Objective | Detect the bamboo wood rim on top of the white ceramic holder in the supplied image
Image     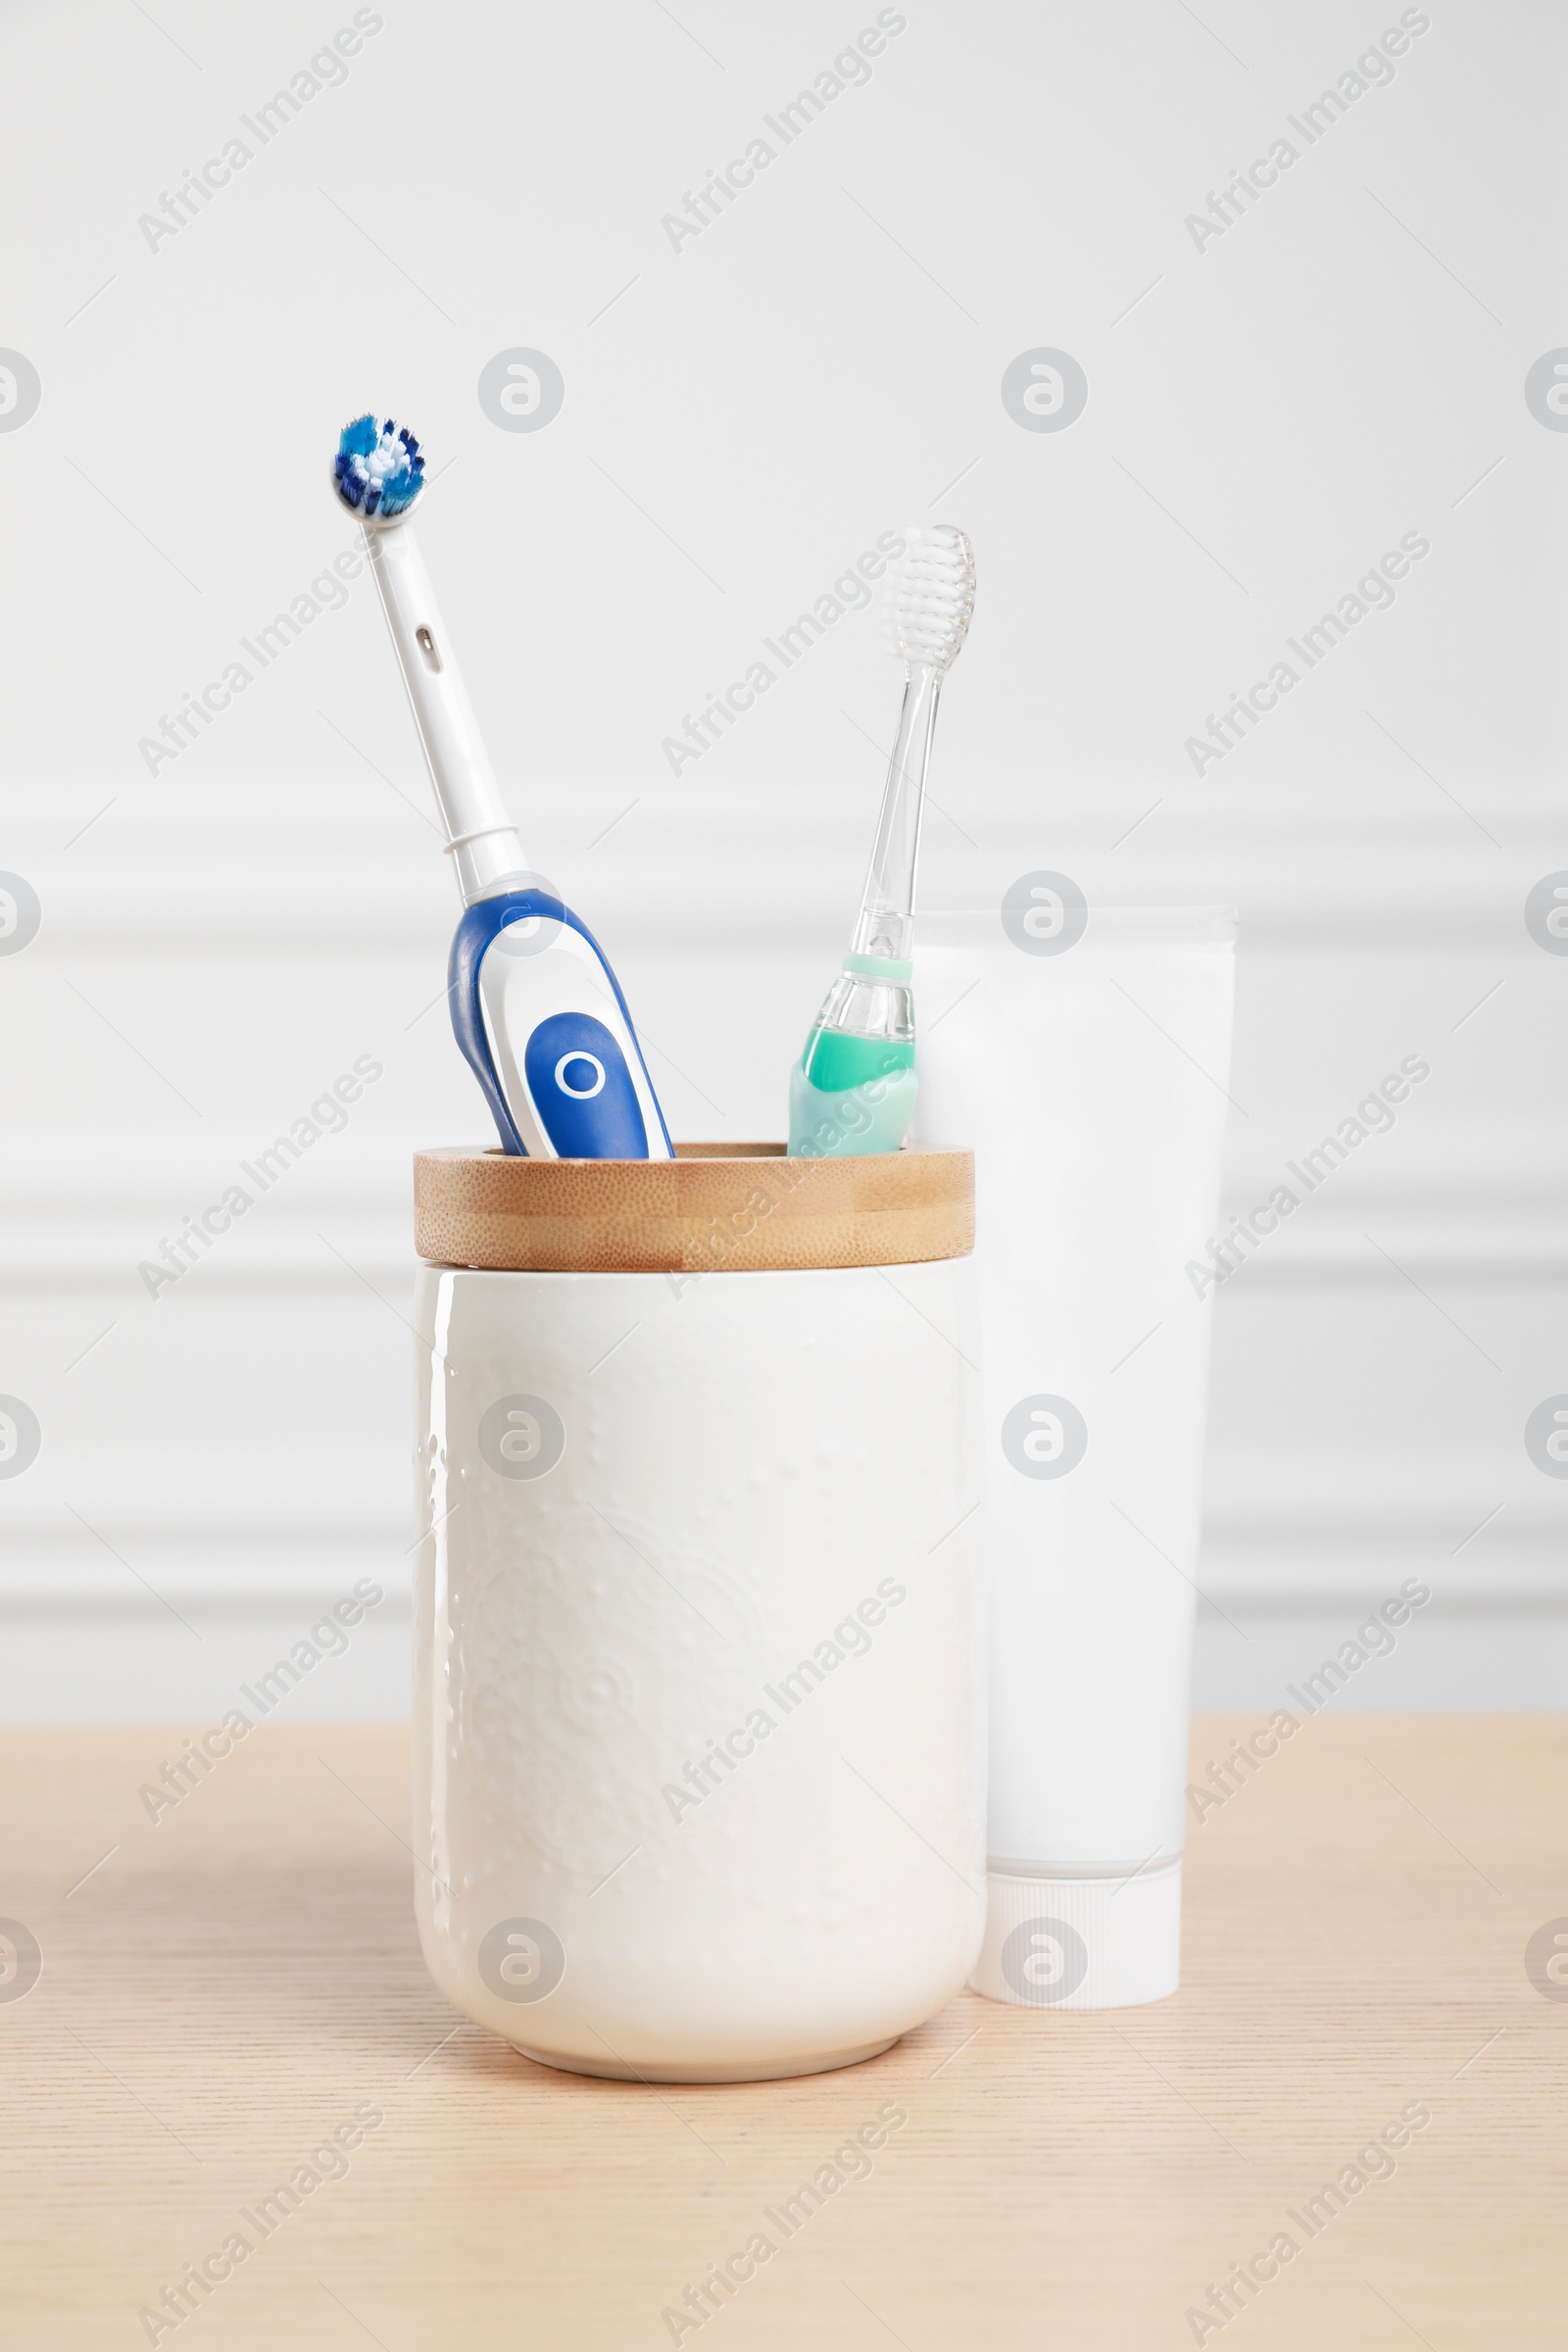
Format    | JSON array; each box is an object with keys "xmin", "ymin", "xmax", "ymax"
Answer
[{"xmin": 414, "ymin": 1143, "xmax": 976, "ymax": 1275}]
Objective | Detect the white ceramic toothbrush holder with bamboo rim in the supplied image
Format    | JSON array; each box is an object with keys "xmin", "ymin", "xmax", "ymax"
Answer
[{"xmin": 414, "ymin": 1146, "xmax": 985, "ymax": 2082}]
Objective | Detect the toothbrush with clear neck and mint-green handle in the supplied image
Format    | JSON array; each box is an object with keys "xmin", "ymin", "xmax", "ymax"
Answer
[{"xmin": 790, "ymin": 522, "xmax": 976, "ymax": 1159}]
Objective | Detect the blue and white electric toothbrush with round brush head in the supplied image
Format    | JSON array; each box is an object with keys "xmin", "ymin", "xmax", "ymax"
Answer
[{"xmin": 334, "ymin": 416, "xmax": 674, "ymax": 1159}]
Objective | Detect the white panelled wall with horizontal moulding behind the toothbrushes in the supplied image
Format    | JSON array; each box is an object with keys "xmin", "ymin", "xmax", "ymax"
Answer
[{"xmin": 0, "ymin": 0, "xmax": 1568, "ymax": 1719}]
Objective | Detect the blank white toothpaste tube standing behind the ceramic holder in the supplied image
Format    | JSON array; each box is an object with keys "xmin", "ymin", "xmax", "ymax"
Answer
[{"xmin": 914, "ymin": 898, "xmax": 1234, "ymax": 2009}]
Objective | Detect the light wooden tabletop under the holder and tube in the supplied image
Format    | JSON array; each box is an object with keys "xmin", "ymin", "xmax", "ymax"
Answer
[{"xmin": 0, "ymin": 1717, "xmax": 1568, "ymax": 2352}]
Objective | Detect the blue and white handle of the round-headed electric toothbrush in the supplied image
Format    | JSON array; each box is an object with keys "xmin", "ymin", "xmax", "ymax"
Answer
[{"xmin": 447, "ymin": 889, "xmax": 674, "ymax": 1159}]
